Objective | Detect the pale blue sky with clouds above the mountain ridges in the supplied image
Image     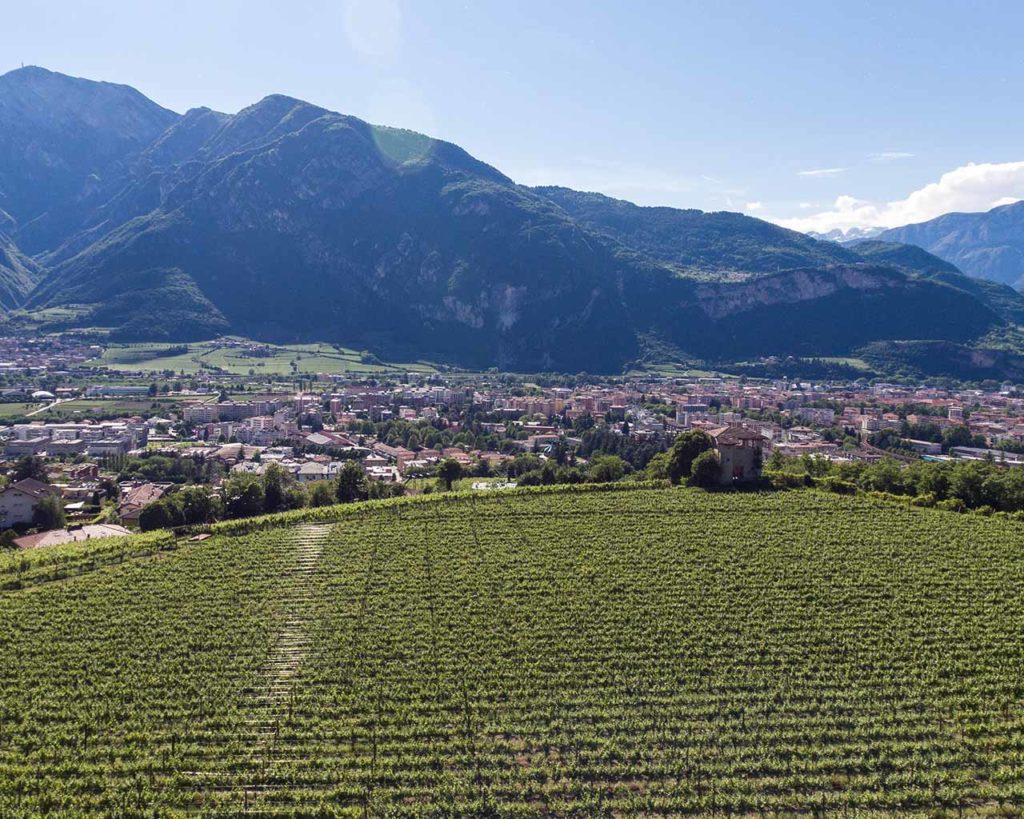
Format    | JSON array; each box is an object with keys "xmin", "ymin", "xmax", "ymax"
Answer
[{"xmin": 0, "ymin": 0, "xmax": 1024, "ymax": 229}]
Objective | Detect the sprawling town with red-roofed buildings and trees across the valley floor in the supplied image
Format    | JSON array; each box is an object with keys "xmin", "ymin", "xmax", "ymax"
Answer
[{"xmin": 0, "ymin": 334, "xmax": 1024, "ymax": 549}]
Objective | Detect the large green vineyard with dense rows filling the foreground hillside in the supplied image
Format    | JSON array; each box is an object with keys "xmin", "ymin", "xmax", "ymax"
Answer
[{"xmin": 0, "ymin": 489, "xmax": 1024, "ymax": 817}]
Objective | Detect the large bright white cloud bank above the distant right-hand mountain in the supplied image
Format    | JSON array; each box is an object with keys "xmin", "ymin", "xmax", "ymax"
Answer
[{"xmin": 776, "ymin": 162, "xmax": 1024, "ymax": 233}]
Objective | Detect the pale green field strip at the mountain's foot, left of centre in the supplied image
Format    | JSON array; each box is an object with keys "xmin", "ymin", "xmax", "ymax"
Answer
[{"xmin": 88, "ymin": 338, "xmax": 434, "ymax": 378}]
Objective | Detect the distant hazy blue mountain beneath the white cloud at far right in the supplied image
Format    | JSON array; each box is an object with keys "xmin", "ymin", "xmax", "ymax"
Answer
[{"xmin": 879, "ymin": 202, "xmax": 1024, "ymax": 290}]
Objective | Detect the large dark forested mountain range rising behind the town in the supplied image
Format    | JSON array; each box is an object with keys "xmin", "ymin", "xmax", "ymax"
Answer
[{"xmin": 0, "ymin": 68, "xmax": 1024, "ymax": 374}]
